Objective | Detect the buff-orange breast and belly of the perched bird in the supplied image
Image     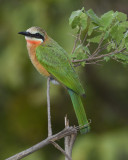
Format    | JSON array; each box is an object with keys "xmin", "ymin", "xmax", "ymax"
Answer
[{"xmin": 27, "ymin": 43, "xmax": 50, "ymax": 77}]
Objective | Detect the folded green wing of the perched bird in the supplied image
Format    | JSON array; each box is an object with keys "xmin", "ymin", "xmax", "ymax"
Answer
[{"xmin": 36, "ymin": 40, "xmax": 84, "ymax": 94}]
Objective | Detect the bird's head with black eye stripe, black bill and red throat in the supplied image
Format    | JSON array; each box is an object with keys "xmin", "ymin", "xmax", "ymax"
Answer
[{"xmin": 19, "ymin": 27, "xmax": 47, "ymax": 44}]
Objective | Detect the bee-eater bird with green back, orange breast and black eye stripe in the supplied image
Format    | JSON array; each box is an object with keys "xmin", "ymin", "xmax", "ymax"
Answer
[{"xmin": 19, "ymin": 27, "xmax": 89, "ymax": 133}]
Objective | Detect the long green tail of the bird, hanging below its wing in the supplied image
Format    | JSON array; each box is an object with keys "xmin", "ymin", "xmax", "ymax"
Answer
[{"xmin": 68, "ymin": 89, "xmax": 90, "ymax": 134}]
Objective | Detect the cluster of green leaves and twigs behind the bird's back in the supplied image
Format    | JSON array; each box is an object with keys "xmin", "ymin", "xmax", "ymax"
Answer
[{"xmin": 69, "ymin": 8, "xmax": 128, "ymax": 65}]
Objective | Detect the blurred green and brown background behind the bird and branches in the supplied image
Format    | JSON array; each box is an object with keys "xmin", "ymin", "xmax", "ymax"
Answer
[{"xmin": 0, "ymin": 0, "xmax": 128, "ymax": 160}]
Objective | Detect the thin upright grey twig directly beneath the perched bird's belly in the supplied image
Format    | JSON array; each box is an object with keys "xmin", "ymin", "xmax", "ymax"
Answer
[{"xmin": 47, "ymin": 77, "xmax": 52, "ymax": 137}]
